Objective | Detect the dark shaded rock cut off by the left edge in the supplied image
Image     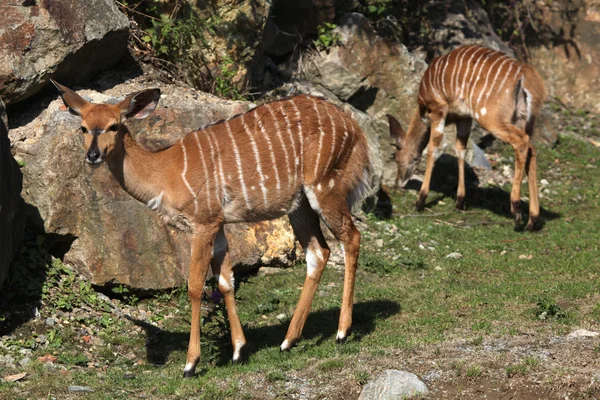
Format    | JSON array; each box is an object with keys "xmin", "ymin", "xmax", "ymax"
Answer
[{"xmin": 0, "ymin": 98, "xmax": 25, "ymax": 287}]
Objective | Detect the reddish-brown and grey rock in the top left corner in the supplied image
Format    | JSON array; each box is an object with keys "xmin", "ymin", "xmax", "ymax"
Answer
[{"xmin": 0, "ymin": 0, "xmax": 129, "ymax": 104}]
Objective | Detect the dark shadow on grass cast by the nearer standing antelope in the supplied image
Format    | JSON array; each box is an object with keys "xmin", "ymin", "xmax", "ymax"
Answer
[{"xmin": 126, "ymin": 300, "xmax": 401, "ymax": 368}]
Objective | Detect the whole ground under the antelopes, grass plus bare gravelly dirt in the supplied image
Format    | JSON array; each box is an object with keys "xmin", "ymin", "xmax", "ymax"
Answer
[{"xmin": 0, "ymin": 111, "xmax": 600, "ymax": 399}]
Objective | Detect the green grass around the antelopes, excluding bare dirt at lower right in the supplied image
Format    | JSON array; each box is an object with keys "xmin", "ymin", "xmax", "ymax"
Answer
[{"xmin": 0, "ymin": 137, "xmax": 600, "ymax": 399}]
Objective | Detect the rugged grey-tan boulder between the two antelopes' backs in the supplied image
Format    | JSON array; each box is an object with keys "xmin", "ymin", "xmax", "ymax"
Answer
[{"xmin": 302, "ymin": 13, "xmax": 427, "ymax": 184}]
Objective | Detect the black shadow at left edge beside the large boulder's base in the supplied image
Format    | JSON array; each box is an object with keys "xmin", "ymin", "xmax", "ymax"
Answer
[{"xmin": 0, "ymin": 204, "xmax": 76, "ymax": 336}]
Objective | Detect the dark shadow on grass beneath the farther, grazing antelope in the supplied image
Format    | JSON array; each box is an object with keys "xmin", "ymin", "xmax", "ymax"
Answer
[{"xmin": 398, "ymin": 154, "xmax": 561, "ymax": 231}]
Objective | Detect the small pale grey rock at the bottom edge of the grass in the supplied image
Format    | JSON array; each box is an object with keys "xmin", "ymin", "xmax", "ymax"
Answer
[{"xmin": 358, "ymin": 369, "xmax": 429, "ymax": 400}]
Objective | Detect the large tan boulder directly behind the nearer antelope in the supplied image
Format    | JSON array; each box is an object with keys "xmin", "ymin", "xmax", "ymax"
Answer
[{"xmin": 10, "ymin": 79, "xmax": 295, "ymax": 289}]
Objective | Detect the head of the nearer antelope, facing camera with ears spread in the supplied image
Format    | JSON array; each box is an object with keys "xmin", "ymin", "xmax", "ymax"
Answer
[{"xmin": 51, "ymin": 80, "xmax": 160, "ymax": 165}]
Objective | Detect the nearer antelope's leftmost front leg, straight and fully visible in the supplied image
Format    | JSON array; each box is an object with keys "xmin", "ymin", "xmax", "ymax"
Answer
[{"xmin": 183, "ymin": 227, "xmax": 217, "ymax": 378}]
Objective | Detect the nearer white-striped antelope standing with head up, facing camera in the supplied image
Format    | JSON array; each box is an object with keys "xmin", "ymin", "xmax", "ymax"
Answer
[{"xmin": 53, "ymin": 81, "xmax": 370, "ymax": 377}]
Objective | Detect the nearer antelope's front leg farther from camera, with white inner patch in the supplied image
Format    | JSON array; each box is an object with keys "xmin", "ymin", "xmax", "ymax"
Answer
[{"xmin": 211, "ymin": 228, "xmax": 246, "ymax": 363}]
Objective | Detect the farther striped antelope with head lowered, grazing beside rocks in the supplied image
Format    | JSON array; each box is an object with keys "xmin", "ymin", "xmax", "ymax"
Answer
[{"xmin": 388, "ymin": 45, "xmax": 546, "ymax": 230}]
